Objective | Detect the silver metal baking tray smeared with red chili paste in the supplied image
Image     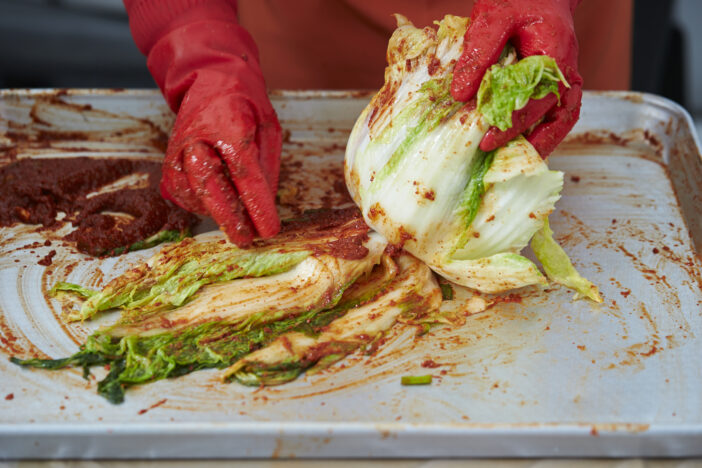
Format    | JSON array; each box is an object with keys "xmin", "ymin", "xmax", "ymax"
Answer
[{"xmin": 0, "ymin": 90, "xmax": 702, "ymax": 458}]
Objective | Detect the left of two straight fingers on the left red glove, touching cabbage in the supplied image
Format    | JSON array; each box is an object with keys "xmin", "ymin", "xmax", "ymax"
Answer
[{"xmin": 183, "ymin": 142, "xmax": 254, "ymax": 247}]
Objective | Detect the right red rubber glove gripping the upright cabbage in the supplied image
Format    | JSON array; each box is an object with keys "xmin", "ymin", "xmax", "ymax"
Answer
[{"xmin": 451, "ymin": 0, "xmax": 583, "ymax": 158}]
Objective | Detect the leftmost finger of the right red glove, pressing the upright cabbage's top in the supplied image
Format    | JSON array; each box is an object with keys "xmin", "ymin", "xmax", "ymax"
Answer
[{"xmin": 451, "ymin": 2, "xmax": 514, "ymax": 102}]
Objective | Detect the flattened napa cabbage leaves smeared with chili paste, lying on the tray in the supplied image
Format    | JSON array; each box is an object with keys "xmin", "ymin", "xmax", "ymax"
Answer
[{"xmin": 11, "ymin": 227, "xmax": 394, "ymax": 403}]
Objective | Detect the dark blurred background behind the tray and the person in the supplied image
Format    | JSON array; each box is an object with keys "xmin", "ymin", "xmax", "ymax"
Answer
[{"xmin": 0, "ymin": 0, "xmax": 702, "ymax": 132}]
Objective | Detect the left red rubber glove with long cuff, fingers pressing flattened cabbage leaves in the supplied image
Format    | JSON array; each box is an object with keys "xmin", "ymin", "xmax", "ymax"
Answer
[{"xmin": 124, "ymin": 0, "xmax": 282, "ymax": 247}]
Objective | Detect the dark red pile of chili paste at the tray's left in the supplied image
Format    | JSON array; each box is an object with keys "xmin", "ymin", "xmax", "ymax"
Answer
[{"xmin": 0, "ymin": 157, "xmax": 197, "ymax": 256}]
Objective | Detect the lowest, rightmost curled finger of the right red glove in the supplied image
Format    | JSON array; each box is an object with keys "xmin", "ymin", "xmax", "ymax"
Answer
[{"xmin": 527, "ymin": 83, "xmax": 583, "ymax": 158}]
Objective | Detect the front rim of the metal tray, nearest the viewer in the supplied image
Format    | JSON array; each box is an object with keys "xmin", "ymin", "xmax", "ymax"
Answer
[{"xmin": 0, "ymin": 422, "xmax": 702, "ymax": 459}]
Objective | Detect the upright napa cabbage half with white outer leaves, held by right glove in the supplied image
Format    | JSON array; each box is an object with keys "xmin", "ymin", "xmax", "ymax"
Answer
[{"xmin": 345, "ymin": 15, "xmax": 599, "ymax": 300}]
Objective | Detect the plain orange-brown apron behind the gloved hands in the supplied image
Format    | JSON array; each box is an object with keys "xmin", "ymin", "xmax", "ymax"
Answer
[{"xmin": 239, "ymin": 0, "xmax": 633, "ymax": 89}]
